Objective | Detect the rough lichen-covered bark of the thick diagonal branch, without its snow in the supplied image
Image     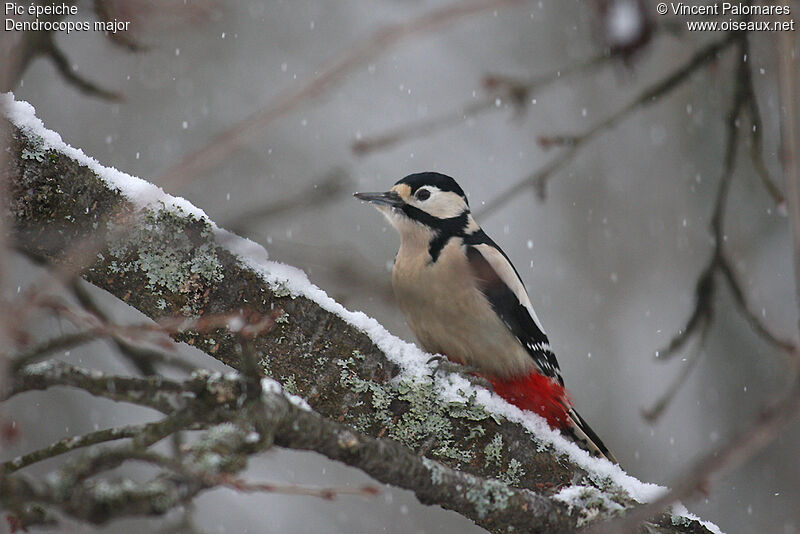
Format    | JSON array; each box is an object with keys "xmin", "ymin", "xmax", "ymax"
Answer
[{"xmin": 3, "ymin": 113, "xmax": 709, "ymax": 533}]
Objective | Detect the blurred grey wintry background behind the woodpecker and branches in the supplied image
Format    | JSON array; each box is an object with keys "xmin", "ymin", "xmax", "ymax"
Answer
[{"xmin": 0, "ymin": 0, "xmax": 800, "ymax": 534}]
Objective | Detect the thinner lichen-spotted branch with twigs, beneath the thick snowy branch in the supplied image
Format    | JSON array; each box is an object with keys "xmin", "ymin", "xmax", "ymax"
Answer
[{"xmin": 0, "ymin": 367, "xmax": 575, "ymax": 534}]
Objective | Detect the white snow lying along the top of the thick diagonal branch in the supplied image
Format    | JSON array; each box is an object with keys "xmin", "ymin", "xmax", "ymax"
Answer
[{"xmin": 0, "ymin": 93, "xmax": 721, "ymax": 534}]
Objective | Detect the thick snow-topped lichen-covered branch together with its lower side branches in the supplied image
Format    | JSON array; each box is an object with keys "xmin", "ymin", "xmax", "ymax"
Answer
[{"xmin": 0, "ymin": 95, "xmax": 719, "ymax": 533}]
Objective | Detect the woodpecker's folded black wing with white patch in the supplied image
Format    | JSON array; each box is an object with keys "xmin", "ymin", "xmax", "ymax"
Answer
[{"xmin": 464, "ymin": 230, "xmax": 564, "ymax": 385}]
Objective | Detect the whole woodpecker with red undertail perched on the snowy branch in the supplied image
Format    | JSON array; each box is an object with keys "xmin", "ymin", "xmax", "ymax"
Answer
[{"xmin": 355, "ymin": 172, "xmax": 616, "ymax": 462}]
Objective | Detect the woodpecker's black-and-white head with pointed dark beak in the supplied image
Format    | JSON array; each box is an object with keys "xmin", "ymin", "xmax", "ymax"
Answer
[{"xmin": 354, "ymin": 172, "xmax": 477, "ymax": 241}]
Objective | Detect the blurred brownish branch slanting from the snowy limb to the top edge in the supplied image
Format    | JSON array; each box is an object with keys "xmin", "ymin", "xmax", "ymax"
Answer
[{"xmin": 158, "ymin": 0, "xmax": 520, "ymax": 190}]
